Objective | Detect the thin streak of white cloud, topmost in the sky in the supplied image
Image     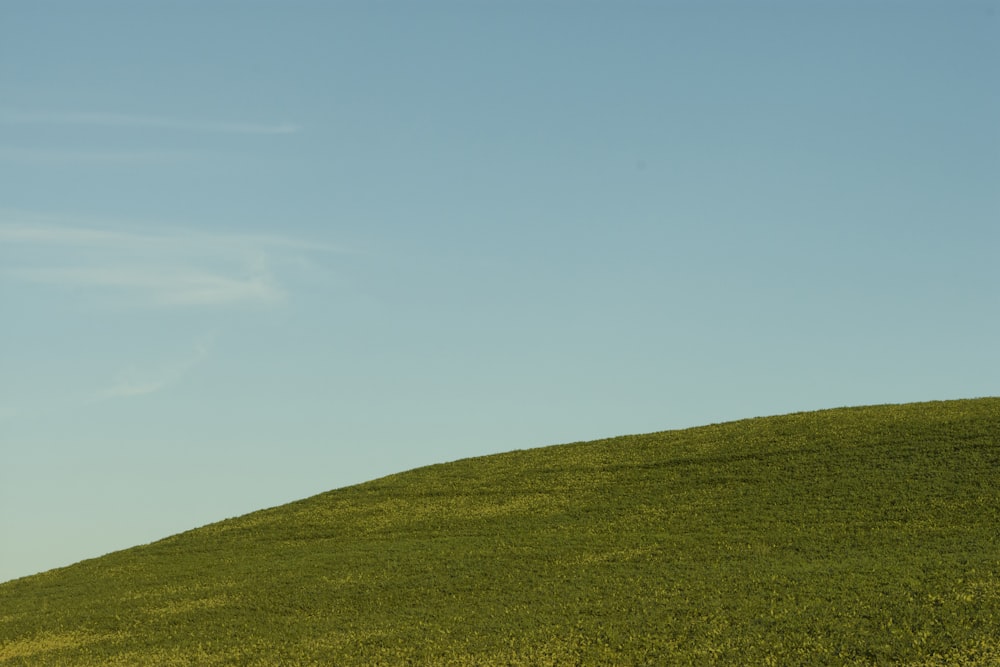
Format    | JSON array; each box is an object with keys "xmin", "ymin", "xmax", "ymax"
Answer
[{"xmin": 0, "ymin": 109, "xmax": 299, "ymax": 134}]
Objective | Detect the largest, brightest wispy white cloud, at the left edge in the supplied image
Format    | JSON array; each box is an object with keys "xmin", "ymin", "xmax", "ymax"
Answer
[{"xmin": 0, "ymin": 214, "xmax": 341, "ymax": 307}]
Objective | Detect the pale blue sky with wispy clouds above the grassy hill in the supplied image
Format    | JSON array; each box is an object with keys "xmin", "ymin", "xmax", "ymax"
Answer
[{"xmin": 0, "ymin": 0, "xmax": 1000, "ymax": 581}]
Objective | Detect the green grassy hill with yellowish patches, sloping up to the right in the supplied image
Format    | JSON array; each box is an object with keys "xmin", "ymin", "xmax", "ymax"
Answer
[{"xmin": 0, "ymin": 398, "xmax": 1000, "ymax": 666}]
